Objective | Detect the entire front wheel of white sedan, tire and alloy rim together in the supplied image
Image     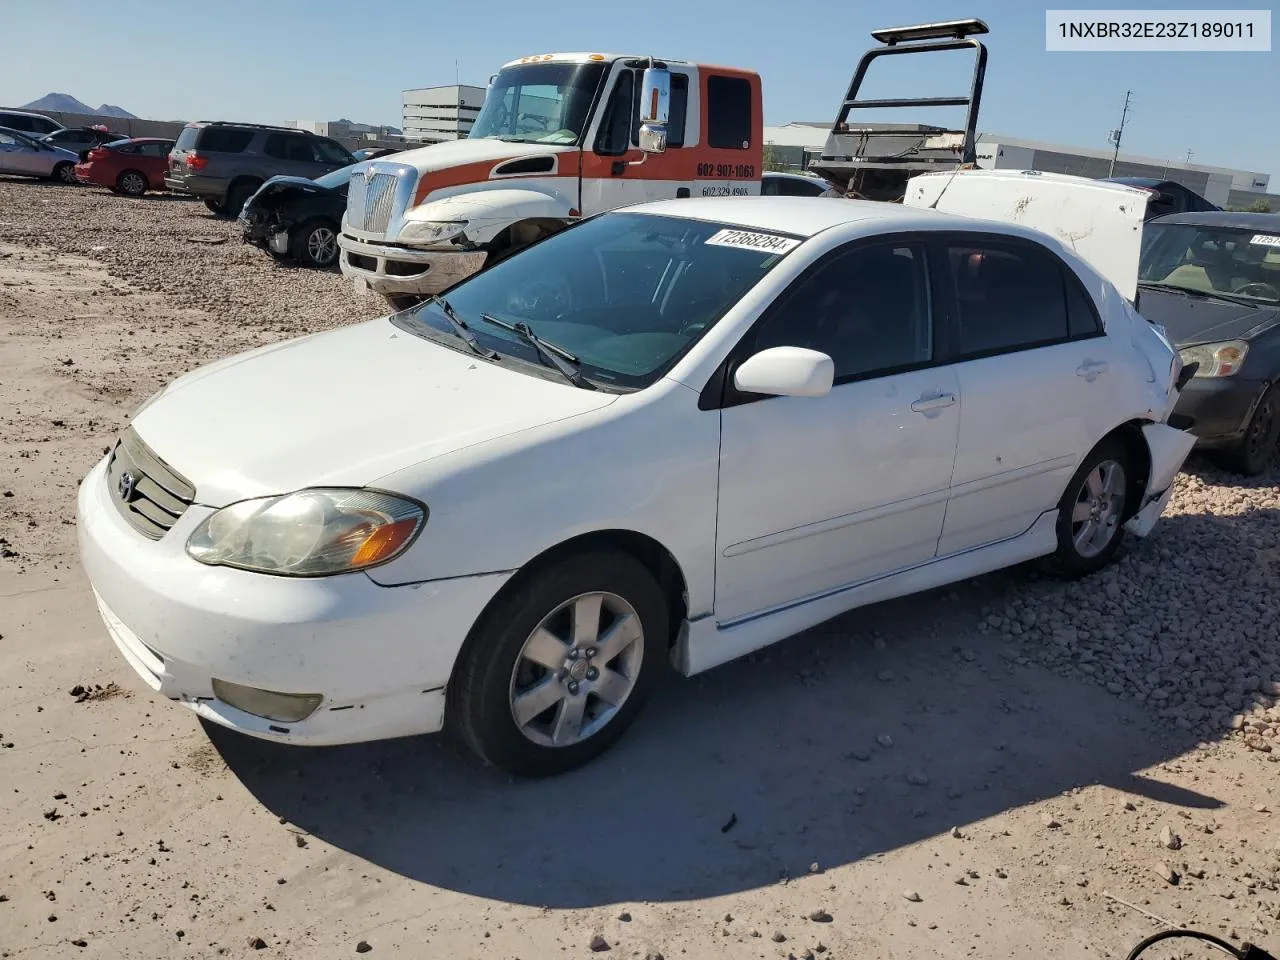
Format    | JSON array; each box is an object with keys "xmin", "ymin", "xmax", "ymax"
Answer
[{"xmin": 448, "ymin": 550, "xmax": 669, "ymax": 777}]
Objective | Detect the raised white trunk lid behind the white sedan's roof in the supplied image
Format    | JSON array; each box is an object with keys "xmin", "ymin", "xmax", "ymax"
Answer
[{"xmin": 902, "ymin": 170, "xmax": 1151, "ymax": 302}]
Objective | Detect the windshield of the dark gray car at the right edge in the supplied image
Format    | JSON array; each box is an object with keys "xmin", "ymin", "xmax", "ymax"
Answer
[{"xmin": 1138, "ymin": 223, "xmax": 1280, "ymax": 302}]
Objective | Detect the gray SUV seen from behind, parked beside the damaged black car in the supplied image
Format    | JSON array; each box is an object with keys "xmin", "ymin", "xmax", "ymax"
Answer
[{"xmin": 164, "ymin": 120, "xmax": 356, "ymax": 216}]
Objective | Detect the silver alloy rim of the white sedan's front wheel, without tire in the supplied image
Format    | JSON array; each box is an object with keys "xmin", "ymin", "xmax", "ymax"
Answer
[{"xmin": 509, "ymin": 593, "xmax": 644, "ymax": 748}]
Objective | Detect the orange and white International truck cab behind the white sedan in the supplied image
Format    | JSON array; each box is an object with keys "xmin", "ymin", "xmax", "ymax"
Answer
[{"xmin": 338, "ymin": 54, "xmax": 764, "ymax": 303}]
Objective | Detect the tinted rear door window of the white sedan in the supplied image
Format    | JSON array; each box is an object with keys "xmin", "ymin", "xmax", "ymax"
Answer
[{"xmin": 947, "ymin": 241, "xmax": 1088, "ymax": 357}]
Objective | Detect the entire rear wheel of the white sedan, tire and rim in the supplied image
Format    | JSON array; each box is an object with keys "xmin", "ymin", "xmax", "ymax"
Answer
[{"xmin": 1053, "ymin": 438, "xmax": 1132, "ymax": 580}]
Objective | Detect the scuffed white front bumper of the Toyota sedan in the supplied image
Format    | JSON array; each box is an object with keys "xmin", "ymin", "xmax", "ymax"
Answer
[{"xmin": 78, "ymin": 458, "xmax": 507, "ymax": 745}]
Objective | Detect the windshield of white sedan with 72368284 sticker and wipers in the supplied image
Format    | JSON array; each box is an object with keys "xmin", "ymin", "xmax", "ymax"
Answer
[{"xmin": 394, "ymin": 212, "xmax": 799, "ymax": 390}]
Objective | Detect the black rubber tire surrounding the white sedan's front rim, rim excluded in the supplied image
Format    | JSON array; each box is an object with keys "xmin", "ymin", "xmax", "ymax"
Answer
[{"xmin": 445, "ymin": 550, "xmax": 671, "ymax": 777}]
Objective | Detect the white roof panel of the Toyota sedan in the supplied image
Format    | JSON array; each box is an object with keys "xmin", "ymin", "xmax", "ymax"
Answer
[{"xmin": 621, "ymin": 197, "xmax": 1003, "ymax": 239}]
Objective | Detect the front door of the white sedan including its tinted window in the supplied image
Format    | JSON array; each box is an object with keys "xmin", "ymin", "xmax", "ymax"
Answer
[{"xmin": 716, "ymin": 239, "xmax": 960, "ymax": 623}]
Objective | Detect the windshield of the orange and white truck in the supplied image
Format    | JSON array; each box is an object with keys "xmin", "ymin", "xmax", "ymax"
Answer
[{"xmin": 468, "ymin": 63, "xmax": 607, "ymax": 145}]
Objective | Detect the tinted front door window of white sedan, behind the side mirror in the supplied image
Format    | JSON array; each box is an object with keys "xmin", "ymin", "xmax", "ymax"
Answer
[{"xmin": 754, "ymin": 243, "xmax": 933, "ymax": 381}]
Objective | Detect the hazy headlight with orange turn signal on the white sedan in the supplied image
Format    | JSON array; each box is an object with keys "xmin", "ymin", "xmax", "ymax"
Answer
[{"xmin": 187, "ymin": 489, "xmax": 426, "ymax": 577}]
